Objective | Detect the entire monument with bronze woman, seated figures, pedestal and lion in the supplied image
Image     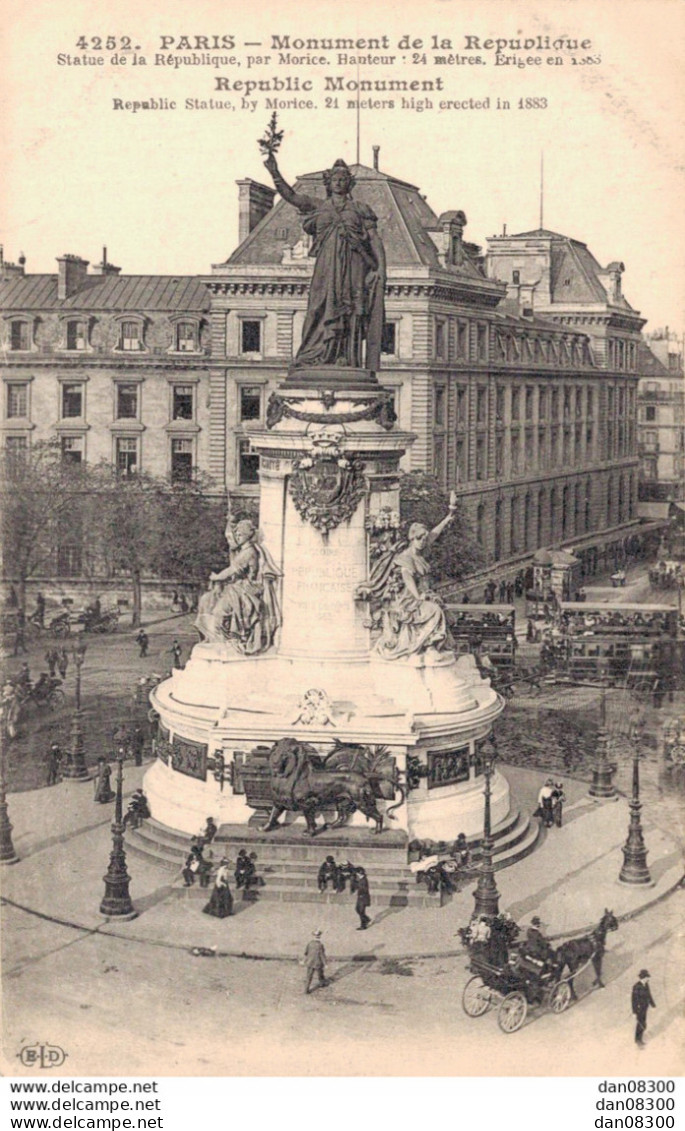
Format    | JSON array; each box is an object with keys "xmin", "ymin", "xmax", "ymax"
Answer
[{"xmin": 145, "ymin": 119, "xmax": 510, "ymax": 844}]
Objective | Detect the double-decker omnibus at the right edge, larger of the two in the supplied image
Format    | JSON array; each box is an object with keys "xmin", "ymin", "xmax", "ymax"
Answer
[{"xmin": 560, "ymin": 602, "xmax": 683, "ymax": 687}]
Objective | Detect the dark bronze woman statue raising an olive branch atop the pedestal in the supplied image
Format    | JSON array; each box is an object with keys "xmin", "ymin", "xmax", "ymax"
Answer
[{"xmin": 265, "ymin": 153, "xmax": 385, "ymax": 372}]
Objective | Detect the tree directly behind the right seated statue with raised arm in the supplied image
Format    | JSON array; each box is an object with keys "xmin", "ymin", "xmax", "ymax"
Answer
[{"xmin": 400, "ymin": 472, "xmax": 485, "ymax": 581}]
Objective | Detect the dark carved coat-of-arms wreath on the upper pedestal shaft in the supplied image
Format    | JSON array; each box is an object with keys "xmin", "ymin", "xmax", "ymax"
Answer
[{"xmin": 289, "ymin": 446, "xmax": 365, "ymax": 535}]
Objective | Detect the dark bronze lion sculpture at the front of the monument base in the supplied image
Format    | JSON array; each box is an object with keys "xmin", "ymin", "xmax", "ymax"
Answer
[{"xmin": 265, "ymin": 739, "xmax": 404, "ymax": 836}]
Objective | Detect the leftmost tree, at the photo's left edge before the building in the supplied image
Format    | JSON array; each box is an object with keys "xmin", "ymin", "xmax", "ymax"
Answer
[{"xmin": 0, "ymin": 440, "xmax": 88, "ymax": 608}]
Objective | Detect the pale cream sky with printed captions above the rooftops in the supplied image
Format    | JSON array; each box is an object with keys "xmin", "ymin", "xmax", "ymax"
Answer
[{"xmin": 0, "ymin": 0, "xmax": 685, "ymax": 334}]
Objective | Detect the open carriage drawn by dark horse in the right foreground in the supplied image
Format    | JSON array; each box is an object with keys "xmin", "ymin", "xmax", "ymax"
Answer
[{"xmin": 461, "ymin": 910, "xmax": 618, "ymax": 1033}]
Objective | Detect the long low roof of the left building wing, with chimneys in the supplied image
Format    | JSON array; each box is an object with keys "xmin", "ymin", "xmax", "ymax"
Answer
[{"xmin": 0, "ymin": 274, "xmax": 210, "ymax": 312}]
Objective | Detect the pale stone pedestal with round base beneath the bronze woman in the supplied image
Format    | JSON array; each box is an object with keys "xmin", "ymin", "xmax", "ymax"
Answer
[{"xmin": 144, "ymin": 370, "xmax": 510, "ymax": 855}]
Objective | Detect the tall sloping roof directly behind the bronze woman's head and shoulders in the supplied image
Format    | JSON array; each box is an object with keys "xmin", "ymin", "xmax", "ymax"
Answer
[{"xmin": 222, "ymin": 165, "xmax": 484, "ymax": 282}]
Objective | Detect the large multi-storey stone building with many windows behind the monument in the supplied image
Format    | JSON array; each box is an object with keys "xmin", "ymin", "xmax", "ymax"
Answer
[{"xmin": 0, "ymin": 154, "xmax": 643, "ymax": 583}]
